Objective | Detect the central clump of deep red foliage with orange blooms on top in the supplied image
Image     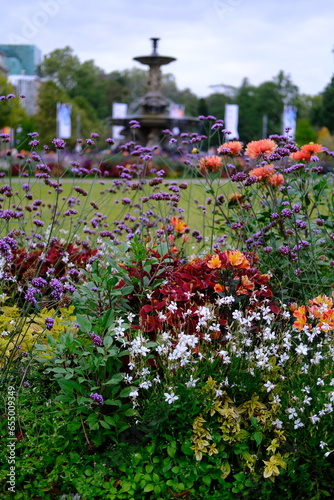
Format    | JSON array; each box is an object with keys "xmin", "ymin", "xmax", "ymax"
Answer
[{"xmin": 120, "ymin": 250, "xmax": 279, "ymax": 338}]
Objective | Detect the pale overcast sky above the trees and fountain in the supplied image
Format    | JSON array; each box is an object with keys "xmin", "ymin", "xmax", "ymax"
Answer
[{"xmin": 0, "ymin": 0, "xmax": 334, "ymax": 97}]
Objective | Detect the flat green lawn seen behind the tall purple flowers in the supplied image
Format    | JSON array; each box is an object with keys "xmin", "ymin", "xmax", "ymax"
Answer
[{"xmin": 6, "ymin": 179, "xmax": 231, "ymax": 243}]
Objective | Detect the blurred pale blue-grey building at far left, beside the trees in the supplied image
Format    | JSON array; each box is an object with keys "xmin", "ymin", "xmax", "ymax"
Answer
[{"xmin": 0, "ymin": 44, "xmax": 42, "ymax": 115}]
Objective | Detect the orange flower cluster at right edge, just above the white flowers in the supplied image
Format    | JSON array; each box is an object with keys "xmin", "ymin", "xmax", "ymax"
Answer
[{"xmin": 291, "ymin": 295, "xmax": 334, "ymax": 332}]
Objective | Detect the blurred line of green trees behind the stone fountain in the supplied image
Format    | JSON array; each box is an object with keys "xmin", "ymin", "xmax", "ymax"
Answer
[{"xmin": 0, "ymin": 46, "xmax": 334, "ymax": 146}]
